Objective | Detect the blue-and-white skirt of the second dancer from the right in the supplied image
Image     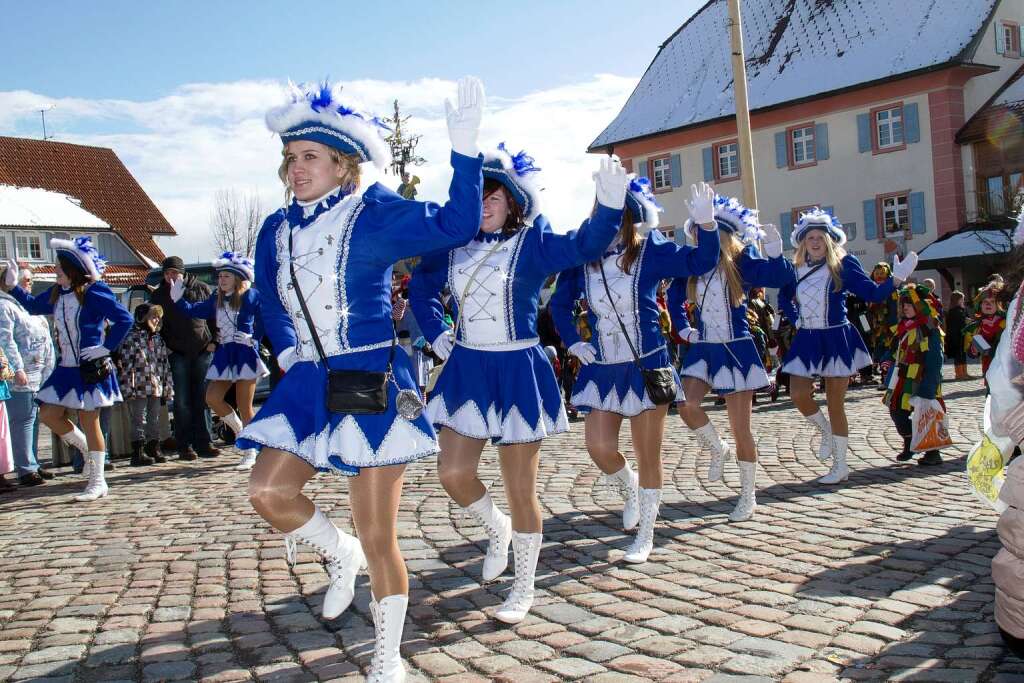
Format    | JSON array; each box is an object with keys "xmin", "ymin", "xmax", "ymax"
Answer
[{"xmin": 679, "ymin": 337, "xmax": 769, "ymax": 396}]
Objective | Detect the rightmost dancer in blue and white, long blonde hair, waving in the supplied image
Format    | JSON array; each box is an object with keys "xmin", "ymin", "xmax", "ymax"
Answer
[{"xmin": 778, "ymin": 208, "xmax": 918, "ymax": 484}]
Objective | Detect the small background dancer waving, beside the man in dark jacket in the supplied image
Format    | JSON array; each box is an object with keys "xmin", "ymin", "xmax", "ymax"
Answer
[{"xmin": 171, "ymin": 252, "xmax": 270, "ymax": 470}]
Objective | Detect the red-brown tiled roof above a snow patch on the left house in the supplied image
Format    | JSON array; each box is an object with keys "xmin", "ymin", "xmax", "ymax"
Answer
[{"xmin": 0, "ymin": 136, "xmax": 177, "ymax": 262}]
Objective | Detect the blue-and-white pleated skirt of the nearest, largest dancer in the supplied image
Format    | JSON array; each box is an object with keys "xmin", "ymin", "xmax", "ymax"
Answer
[{"xmin": 236, "ymin": 347, "xmax": 437, "ymax": 475}]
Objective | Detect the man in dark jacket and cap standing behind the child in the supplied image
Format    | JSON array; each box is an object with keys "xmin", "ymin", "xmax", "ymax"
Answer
[{"xmin": 151, "ymin": 256, "xmax": 218, "ymax": 460}]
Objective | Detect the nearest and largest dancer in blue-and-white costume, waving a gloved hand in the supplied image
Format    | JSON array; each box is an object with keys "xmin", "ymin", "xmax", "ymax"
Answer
[{"xmin": 238, "ymin": 79, "xmax": 483, "ymax": 681}]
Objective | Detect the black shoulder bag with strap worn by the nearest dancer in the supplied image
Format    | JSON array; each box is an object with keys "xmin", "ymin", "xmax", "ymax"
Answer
[{"xmin": 288, "ymin": 226, "xmax": 397, "ymax": 415}]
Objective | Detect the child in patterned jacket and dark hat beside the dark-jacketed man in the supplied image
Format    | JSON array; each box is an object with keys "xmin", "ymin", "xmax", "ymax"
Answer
[{"xmin": 118, "ymin": 303, "xmax": 174, "ymax": 467}]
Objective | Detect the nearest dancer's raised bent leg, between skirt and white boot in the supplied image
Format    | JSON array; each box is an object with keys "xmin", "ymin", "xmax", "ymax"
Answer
[{"xmin": 249, "ymin": 449, "xmax": 316, "ymax": 533}]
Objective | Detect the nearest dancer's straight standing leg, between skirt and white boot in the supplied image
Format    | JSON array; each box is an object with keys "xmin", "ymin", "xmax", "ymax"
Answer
[{"xmin": 348, "ymin": 464, "xmax": 409, "ymax": 601}]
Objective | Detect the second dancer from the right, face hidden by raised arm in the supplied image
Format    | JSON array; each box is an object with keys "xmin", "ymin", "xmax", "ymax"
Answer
[{"xmin": 668, "ymin": 183, "xmax": 793, "ymax": 521}]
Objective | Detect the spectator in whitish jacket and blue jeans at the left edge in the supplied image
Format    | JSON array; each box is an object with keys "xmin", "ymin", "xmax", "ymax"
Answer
[{"xmin": 0, "ymin": 265, "xmax": 55, "ymax": 486}]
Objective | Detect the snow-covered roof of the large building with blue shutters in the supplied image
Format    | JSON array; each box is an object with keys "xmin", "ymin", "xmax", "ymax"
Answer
[{"xmin": 591, "ymin": 0, "xmax": 997, "ymax": 147}]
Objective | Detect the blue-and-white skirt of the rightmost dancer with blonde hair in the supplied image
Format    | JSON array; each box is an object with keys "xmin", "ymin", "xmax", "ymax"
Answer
[{"xmin": 782, "ymin": 323, "xmax": 871, "ymax": 377}]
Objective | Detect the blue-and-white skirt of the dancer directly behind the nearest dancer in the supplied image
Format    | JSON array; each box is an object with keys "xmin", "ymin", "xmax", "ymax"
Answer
[{"xmin": 427, "ymin": 344, "xmax": 569, "ymax": 445}]
